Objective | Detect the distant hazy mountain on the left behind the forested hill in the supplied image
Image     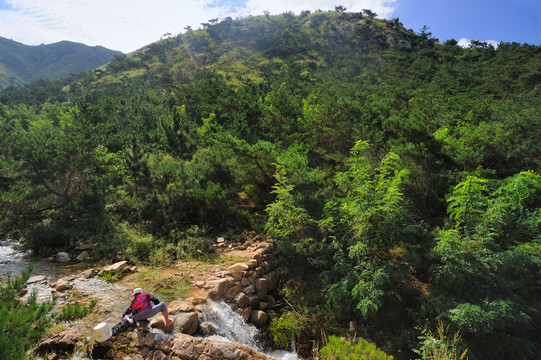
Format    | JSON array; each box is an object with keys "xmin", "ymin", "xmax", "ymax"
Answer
[{"xmin": 0, "ymin": 37, "xmax": 122, "ymax": 89}]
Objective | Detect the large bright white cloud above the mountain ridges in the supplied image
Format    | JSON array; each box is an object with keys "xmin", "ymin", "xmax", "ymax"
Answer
[{"xmin": 0, "ymin": 0, "xmax": 397, "ymax": 52}]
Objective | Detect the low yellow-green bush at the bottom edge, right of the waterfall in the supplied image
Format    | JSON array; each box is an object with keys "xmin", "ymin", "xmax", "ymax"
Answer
[{"xmin": 320, "ymin": 335, "xmax": 393, "ymax": 360}]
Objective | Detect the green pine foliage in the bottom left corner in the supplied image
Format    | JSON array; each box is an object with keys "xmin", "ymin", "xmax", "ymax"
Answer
[{"xmin": 0, "ymin": 269, "xmax": 55, "ymax": 360}]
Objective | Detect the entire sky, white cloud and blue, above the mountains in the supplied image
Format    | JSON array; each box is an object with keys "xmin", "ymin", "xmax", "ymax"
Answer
[{"xmin": 0, "ymin": 0, "xmax": 541, "ymax": 53}]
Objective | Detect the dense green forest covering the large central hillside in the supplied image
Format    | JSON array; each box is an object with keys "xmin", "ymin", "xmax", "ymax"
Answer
[{"xmin": 0, "ymin": 12, "xmax": 541, "ymax": 359}]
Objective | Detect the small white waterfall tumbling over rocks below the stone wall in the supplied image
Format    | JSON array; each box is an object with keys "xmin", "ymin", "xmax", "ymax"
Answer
[{"xmin": 204, "ymin": 303, "xmax": 300, "ymax": 360}]
